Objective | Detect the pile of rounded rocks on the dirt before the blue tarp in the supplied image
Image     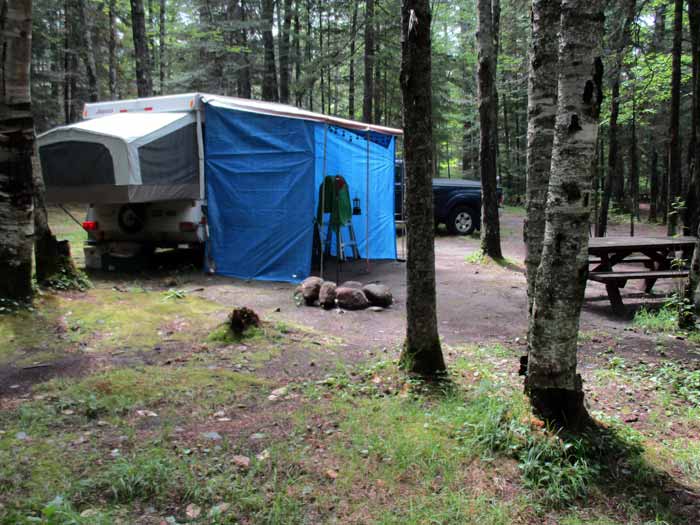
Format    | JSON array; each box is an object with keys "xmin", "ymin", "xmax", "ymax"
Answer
[{"xmin": 294, "ymin": 277, "xmax": 394, "ymax": 310}]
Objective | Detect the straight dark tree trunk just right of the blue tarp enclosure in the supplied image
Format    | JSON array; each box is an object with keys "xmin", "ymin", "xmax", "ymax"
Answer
[{"xmin": 396, "ymin": 0, "xmax": 445, "ymax": 376}]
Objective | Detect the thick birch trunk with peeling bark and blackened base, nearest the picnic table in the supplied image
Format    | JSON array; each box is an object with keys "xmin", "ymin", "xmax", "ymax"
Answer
[{"xmin": 525, "ymin": 0, "xmax": 604, "ymax": 429}]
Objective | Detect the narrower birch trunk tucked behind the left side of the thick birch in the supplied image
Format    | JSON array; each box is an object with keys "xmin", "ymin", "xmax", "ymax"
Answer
[{"xmin": 524, "ymin": 0, "xmax": 561, "ymax": 314}]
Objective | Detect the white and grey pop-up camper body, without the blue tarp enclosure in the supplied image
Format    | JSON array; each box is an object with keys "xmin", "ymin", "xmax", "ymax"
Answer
[{"xmin": 37, "ymin": 94, "xmax": 207, "ymax": 269}]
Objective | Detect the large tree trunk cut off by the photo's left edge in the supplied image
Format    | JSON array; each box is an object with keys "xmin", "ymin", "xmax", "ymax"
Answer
[{"xmin": 0, "ymin": 0, "xmax": 34, "ymax": 301}]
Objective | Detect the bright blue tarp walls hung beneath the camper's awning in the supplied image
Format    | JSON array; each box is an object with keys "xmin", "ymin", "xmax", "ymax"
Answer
[{"xmin": 204, "ymin": 100, "xmax": 396, "ymax": 282}]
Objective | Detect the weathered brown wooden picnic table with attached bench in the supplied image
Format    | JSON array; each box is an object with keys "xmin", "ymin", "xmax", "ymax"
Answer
[{"xmin": 588, "ymin": 237, "xmax": 696, "ymax": 314}]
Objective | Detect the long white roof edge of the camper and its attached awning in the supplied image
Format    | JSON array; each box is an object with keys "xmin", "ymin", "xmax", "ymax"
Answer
[{"xmin": 83, "ymin": 93, "xmax": 403, "ymax": 135}]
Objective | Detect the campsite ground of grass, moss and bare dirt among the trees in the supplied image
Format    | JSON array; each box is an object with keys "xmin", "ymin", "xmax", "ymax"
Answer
[{"xmin": 0, "ymin": 208, "xmax": 700, "ymax": 525}]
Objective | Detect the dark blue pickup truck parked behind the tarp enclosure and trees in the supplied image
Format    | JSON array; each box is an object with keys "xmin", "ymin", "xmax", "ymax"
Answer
[{"xmin": 394, "ymin": 163, "xmax": 503, "ymax": 235}]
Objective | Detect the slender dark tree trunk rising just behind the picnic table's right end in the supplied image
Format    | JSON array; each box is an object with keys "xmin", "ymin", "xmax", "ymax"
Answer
[{"xmin": 666, "ymin": 0, "xmax": 683, "ymax": 235}]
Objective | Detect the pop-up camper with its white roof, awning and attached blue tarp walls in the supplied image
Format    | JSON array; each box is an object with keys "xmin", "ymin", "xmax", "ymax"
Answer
[{"xmin": 38, "ymin": 94, "xmax": 401, "ymax": 281}]
